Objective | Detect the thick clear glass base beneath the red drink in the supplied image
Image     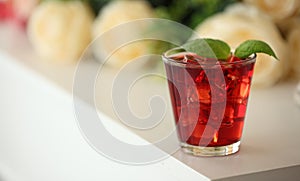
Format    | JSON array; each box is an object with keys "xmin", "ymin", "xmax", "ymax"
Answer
[{"xmin": 181, "ymin": 141, "xmax": 240, "ymax": 156}]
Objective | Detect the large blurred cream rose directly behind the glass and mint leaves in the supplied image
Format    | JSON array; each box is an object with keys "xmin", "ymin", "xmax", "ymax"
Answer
[{"xmin": 195, "ymin": 4, "xmax": 289, "ymax": 87}]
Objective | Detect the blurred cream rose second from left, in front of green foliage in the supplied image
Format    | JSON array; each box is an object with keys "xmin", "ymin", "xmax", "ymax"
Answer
[{"xmin": 93, "ymin": 0, "xmax": 154, "ymax": 67}]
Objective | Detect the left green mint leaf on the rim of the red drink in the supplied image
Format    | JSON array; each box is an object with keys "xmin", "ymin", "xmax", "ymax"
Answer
[{"xmin": 182, "ymin": 38, "xmax": 230, "ymax": 60}]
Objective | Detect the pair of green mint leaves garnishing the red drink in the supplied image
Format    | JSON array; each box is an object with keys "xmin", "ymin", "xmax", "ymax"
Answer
[{"xmin": 182, "ymin": 38, "xmax": 278, "ymax": 60}]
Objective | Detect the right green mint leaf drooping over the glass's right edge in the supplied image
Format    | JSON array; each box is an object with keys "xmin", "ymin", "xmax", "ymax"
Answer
[{"xmin": 234, "ymin": 40, "xmax": 278, "ymax": 60}]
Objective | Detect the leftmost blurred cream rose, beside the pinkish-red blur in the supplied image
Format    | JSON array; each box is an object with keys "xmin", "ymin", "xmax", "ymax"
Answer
[{"xmin": 28, "ymin": 1, "xmax": 93, "ymax": 63}]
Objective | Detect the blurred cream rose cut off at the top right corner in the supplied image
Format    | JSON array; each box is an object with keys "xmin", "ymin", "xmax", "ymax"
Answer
[{"xmin": 244, "ymin": 0, "xmax": 300, "ymax": 20}]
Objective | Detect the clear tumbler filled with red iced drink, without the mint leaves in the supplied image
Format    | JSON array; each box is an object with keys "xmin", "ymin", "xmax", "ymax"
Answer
[{"xmin": 162, "ymin": 48, "xmax": 256, "ymax": 156}]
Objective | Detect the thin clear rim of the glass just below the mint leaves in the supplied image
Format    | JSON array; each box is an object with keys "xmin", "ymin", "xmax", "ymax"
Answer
[{"xmin": 162, "ymin": 47, "xmax": 257, "ymax": 67}]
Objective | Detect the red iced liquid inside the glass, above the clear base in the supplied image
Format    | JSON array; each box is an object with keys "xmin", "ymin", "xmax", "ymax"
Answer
[{"xmin": 165, "ymin": 53, "xmax": 255, "ymax": 146}]
